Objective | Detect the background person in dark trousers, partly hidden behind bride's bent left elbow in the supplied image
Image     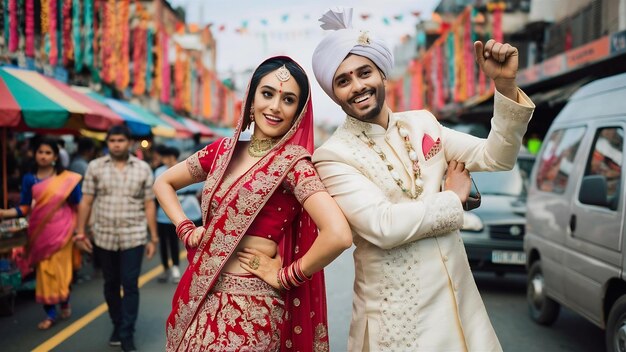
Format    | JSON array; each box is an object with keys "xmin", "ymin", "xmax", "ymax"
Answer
[{"xmin": 154, "ymin": 147, "xmax": 204, "ymax": 283}]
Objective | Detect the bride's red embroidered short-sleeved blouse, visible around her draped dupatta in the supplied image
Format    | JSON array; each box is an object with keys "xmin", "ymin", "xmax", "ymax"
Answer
[{"xmin": 186, "ymin": 140, "xmax": 326, "ymax": 243}]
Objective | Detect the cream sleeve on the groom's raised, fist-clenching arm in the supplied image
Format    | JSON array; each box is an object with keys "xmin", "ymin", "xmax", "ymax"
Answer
[{"xmin": 441, "ymin": 89, "xmax": 535, "ymax": 171}]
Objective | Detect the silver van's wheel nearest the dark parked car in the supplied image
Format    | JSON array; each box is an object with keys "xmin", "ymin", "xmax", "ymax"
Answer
[{"xmin": 526, "ymin": 260, "xmax": 561, "ymax": 325}]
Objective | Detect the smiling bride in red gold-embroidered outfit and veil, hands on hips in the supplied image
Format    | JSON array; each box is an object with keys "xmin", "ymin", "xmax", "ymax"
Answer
[{"xmin": 154, "ymin": 57, "xmax": 352, "ymax": 351}]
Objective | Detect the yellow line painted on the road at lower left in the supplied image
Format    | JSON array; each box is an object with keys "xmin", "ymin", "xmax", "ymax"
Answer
[{"xmin": 33, "ymin": 251, "xmax": 187, "ymax": 352}]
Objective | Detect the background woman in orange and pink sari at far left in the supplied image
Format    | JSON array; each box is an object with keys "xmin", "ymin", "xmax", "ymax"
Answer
[{"xmin": 0, "ymin": 139, "xmax": 81, "ymax": 330}]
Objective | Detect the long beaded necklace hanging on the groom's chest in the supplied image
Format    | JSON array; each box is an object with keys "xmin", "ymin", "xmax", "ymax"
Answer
[{"xmin": 357, "ymin": 121, "xmax": 424, "ymax": 199}]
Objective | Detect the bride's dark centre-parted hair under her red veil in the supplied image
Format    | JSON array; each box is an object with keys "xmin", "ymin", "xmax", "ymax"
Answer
[{"xmin": 242, "ymin": 56, "xmax": 309, "ymax": 130}]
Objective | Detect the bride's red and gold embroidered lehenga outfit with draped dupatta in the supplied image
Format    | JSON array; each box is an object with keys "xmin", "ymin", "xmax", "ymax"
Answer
[{"xmin": 166, "ymin": 56, "xmax": 329, "ymax": 351}]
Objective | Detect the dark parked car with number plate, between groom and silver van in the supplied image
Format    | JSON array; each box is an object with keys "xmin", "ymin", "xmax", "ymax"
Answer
[{"xmin": 461, "ymin": 154, "xmax": 532, "ymax": 275}]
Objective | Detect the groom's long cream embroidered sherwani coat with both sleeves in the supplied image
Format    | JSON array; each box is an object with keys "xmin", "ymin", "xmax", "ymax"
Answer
[{"xmin": 313, "ymin": 90, "xmax": 534, "ymax": 351}]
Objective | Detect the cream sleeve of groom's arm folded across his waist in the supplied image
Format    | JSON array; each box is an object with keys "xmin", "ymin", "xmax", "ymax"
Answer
[{"xmin": 314, "ymin": 155, "xmax": 463, "ymax": 249}]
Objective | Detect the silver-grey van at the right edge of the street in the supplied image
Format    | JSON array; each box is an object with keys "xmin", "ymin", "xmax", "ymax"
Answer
[{"xmin": 524, "ymin": 74, "xmax": 626, "ymax": 351}]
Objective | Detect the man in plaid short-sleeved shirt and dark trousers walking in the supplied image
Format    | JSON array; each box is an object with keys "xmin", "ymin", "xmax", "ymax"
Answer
[{"xmin": 74, "ymin": 126, "xmax": 159, "ymax": 351}]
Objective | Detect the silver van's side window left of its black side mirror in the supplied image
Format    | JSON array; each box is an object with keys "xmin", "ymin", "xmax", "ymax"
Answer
[{"xmin": 537, "ymin": 127, "xmax": 585, "ymax": 194}]
